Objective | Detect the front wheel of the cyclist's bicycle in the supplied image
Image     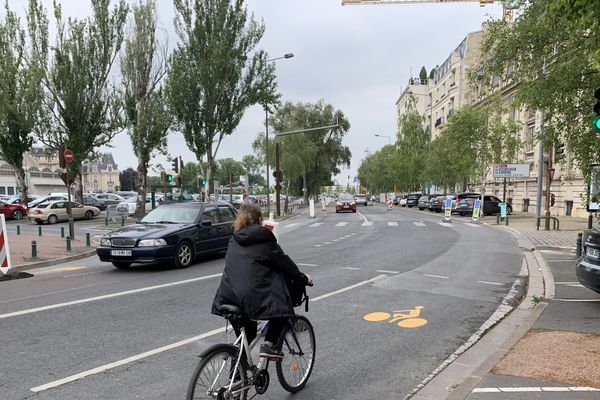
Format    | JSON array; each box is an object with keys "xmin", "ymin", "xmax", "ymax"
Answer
[{"xmin": 275, "ymin": 316, "xmax": 316, "ymax": 393}]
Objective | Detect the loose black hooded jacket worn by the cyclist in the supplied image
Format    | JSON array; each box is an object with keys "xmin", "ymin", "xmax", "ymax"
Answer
[{"xmin": 212, "ymin": 225, "xmax": 307, "ymax": 320}]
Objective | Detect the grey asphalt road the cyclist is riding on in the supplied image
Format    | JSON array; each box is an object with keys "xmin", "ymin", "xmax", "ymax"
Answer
[{"xmin": 0, "ymin": 206, "xmax": 522, "ymax": 400}]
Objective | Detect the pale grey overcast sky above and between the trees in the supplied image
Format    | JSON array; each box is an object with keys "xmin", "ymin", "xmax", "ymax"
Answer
[{"xmin": 15, "ymin": 0, "xmax": 502, "ymax": 184}]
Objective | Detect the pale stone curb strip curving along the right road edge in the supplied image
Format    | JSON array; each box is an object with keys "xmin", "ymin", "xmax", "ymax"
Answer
[{"xmin": 404, "ymin": 223, "xmax": 554, "ymax": 400}]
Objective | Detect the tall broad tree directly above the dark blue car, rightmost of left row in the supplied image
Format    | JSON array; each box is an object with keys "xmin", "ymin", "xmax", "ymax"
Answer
[{"xmin": 168, "ymin": 0, "xmax": 279, "ymax": 197}]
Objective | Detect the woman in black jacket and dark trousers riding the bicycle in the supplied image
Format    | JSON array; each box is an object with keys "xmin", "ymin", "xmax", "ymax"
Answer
[{"xmin": 212, "ymin": 203, "xmax": 312, "ymax": 359}]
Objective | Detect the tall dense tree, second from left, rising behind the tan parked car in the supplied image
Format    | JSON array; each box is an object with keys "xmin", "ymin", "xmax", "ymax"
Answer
[{"xmin": 29, "ymin": 0, "xmax": 128, "ymax": 199}]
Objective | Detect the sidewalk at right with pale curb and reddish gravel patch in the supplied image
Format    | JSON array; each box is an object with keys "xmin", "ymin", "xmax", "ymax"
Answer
[{"xmin": 407, "ymin": 213, "xmax": 600, "ymax": 400}]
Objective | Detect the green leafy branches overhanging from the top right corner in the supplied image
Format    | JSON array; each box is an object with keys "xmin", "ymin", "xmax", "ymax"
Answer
[{"xmin": 475, "ymin": 0, "xmax": 600, "ymax": 177}]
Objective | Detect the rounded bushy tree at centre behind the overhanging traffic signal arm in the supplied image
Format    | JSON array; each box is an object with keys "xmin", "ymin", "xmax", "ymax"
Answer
[{"xmin": 269, "ymin": 101, "xmax": 351, "ymax": 202}]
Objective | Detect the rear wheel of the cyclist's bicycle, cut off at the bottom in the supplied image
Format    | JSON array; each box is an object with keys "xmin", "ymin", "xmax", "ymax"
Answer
[{"xmin": 186, "ymin": 345, "xmax": 248, "ymax": 400}]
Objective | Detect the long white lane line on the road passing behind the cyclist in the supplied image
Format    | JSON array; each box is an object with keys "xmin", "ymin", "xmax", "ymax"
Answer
[{"xmin": 29, "ymin": 274, "xmax": 387, "ymax": 393}]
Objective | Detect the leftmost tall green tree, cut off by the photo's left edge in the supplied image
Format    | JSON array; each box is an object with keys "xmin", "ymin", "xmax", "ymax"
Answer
[{"xmin": 0, "ymin": 2, "xmax": 44, "ymax": 204}]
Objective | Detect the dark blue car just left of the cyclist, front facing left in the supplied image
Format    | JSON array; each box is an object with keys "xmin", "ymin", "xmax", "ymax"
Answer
[{"xmin": 96, "ymin": 201, "xmax": 237, "ymax": 268}]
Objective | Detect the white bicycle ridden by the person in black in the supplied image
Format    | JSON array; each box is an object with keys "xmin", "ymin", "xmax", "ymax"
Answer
[{"xmin": 186, "ymin": 285, "xmax": 316, "ymax": 400}]
